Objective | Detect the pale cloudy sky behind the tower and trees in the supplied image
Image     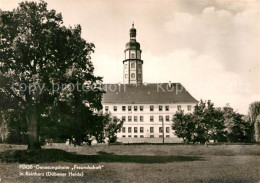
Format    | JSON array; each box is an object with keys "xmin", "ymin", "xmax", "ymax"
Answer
[{"xmin": 0, "ymin": 0, "xmax": 260, "ymax": 114}]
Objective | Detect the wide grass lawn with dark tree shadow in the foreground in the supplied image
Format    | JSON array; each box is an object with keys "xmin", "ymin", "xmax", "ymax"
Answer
[{"xmin": 0, "ymin": 144, "xmax": 260, "ymax": 183}]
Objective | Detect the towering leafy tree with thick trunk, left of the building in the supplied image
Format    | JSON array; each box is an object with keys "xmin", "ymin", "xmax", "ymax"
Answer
[{"xmin": 0, "ymin": 1, "xmax": 102, "ymax": 149}]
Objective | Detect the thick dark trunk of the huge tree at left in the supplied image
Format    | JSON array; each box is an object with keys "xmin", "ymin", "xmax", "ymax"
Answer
[{"xmin": 26, "ymin": 106, "xmax": 41, "ymax": 149}]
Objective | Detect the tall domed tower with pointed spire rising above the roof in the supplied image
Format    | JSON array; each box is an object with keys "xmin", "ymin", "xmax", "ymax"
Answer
[{"xmin": 123, "ymin": 23, "xmax": 143, "ymax": 84}]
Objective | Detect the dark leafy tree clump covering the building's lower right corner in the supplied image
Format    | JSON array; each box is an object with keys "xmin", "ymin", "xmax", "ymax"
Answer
[{"xmin": 172, "ymin": 100, "xmax": 251, "ymax": 143}]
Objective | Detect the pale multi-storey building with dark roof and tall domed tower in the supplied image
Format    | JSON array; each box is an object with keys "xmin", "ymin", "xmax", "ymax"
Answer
[{"xmin": 102, "ymin": 25, "xmax": 197, "ymax": 142}]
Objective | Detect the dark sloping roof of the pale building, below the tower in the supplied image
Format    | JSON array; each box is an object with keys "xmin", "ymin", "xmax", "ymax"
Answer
[{"xmin": 102, "ymin": 83, "xmax": 198, "ymax": 104}]
